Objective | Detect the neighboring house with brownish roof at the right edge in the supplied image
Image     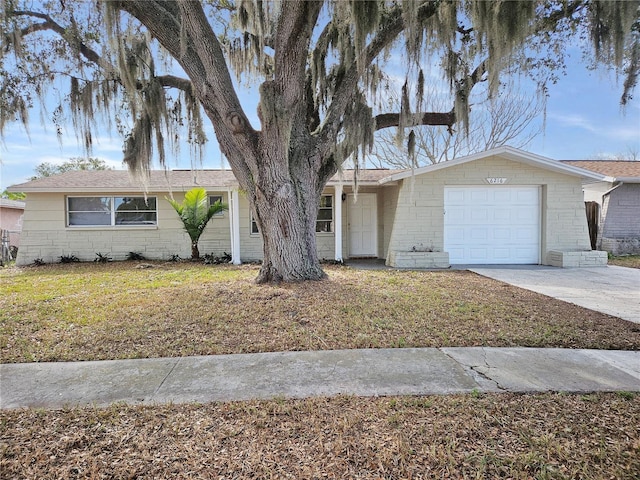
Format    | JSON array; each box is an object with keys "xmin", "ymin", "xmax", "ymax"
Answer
[{"xmin": 562, "ymin": 160, "xmax": 640, "ymax": 255}]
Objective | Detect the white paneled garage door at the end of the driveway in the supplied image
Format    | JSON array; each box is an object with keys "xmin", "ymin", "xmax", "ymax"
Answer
[{"xmin": 444, "ymin": 186, "xmax": 540, "ymax": 265}]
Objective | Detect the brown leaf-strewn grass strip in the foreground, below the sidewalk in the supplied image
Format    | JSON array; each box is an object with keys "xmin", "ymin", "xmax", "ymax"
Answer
[{"xmin": 0, "ymin": 394, "xmax": 640, "ymax": 480}]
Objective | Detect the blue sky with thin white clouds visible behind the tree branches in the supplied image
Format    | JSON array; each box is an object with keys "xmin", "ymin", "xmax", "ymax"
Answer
[{"xmin": 0, "ymin": 53, "xmax": 640, "ymax": 191}]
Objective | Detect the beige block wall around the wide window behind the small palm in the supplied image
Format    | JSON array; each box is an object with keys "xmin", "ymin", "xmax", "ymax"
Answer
[{"xmin": 16, "ymin": 191, "xmax": 231, "ymax": 265}]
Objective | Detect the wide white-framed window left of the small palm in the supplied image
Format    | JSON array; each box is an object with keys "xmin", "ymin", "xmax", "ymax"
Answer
[{"xmin": 67, "ymin": 197, "xmax": 158, "ymax": 227}]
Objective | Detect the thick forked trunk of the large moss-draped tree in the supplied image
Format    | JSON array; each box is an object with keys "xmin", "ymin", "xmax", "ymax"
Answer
[{"xmin": 127, "ymin": 1, "xmax": 332, "ymax": 283}]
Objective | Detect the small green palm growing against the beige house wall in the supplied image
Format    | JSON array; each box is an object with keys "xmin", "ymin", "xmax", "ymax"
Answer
[{"xmin": 165, "ymin": 187, "xmax": 228, "ymax": 259}]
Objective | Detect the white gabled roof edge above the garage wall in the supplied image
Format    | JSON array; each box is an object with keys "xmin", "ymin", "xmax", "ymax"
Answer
[{"xmin": 380, "ymin": 146, "xmax": 606, "ymax": 183}]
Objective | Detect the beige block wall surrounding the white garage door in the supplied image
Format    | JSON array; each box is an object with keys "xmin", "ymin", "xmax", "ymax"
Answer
[{"xmin": 387, "ymin": 157, "xmax": 591, "ymax": 264}]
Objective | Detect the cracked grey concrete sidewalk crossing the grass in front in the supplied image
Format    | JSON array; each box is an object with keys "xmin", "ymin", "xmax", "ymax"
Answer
[{"xmin": 0, "ymin": 347, "xmax": 640, "ymax": 409}]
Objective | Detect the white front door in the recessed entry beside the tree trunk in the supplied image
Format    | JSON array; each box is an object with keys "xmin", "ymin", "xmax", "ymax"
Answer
[{"xmin": 349, "ymin": 193, "xmax": 378, "ymax": 257}]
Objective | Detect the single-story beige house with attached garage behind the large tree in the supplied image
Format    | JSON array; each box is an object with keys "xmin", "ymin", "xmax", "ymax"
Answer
[{"xmin": 10, "ymin": 147, "xmax": 607, "ymax": 268}]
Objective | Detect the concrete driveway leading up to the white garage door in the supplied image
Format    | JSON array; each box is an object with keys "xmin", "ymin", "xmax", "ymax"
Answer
[{"xmin": 468, "ymin": 265, "xmax": 640, "ymax": 323}]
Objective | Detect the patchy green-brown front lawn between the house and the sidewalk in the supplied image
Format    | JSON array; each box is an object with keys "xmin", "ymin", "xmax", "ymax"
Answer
[{"xmin": 0, "ymin": 262, "xmax": 640, "ymax": 363}]
